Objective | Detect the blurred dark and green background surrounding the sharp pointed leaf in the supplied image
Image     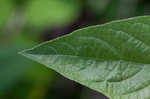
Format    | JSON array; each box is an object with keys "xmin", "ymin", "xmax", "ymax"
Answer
[{"xmin": 0, "ymin": 0, "xmax": 150, "ymax": 99}]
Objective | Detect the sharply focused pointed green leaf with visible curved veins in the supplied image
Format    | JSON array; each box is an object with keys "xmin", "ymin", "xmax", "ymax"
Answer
[{"xmin": 22, "ymin": 16, "xmax": 150, "ymax": 99}]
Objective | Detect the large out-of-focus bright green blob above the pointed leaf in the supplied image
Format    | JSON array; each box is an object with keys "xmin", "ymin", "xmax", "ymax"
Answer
[{"xmin": 25, "ymin": 0, "xmax": 80, "ymax": 26}]
